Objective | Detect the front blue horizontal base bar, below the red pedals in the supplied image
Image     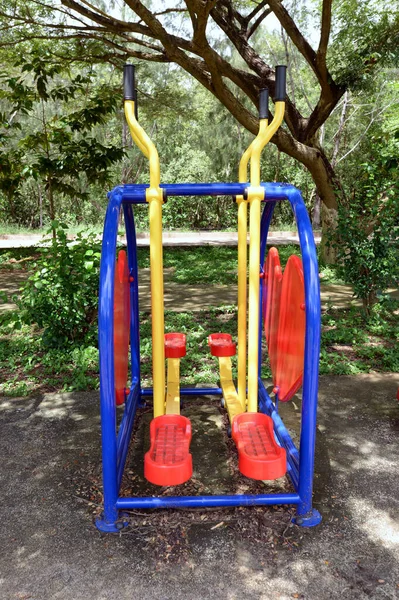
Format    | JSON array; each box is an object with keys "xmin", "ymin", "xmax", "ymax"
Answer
[{"xmin": 116, "ymin": 494, "xmax": 301, "ymax": 510}]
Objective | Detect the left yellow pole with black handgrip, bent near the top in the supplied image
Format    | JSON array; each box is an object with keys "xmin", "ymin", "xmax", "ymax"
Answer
[{"xmin": 124, "ymin": 65, "xmax": 165, "ymax": 417}]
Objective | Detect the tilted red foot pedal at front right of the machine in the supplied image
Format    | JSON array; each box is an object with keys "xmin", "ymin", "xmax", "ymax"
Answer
[{"xmin": 231, "ymin": 413, "xmax": 287, "ymax": 479}]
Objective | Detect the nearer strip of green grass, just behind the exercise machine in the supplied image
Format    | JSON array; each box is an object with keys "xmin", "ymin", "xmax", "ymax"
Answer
[{"xmin": 0, "ymin": 300, "xmax": 399, "ymax": 396}]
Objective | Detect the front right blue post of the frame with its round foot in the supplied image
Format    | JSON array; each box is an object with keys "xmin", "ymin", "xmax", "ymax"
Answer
[{"xmin": 287, "ymin": 186, "xmax": 321, "ymax": 527}]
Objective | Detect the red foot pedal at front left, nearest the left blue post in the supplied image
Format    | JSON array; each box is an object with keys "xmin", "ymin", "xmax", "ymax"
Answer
[{"xmin": 144, "ymin": 415, "xmax": 193, "ymax": 486}]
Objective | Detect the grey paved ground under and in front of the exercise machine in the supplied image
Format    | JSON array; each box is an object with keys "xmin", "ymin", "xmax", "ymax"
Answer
[{"xmin": 0, "ymin": 374, "xmax": 399, "ymax": 600}]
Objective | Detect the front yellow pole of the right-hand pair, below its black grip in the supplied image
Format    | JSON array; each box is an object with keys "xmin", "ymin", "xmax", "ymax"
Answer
[{"xmin": 248, "ymin": 95, "xmax": 285, "ymax": 412}]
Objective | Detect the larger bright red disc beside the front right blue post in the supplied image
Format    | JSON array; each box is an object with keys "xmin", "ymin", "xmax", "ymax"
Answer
[{"xmin": 274, "ymin": 255, "xmax": 306, "ymax": 402}]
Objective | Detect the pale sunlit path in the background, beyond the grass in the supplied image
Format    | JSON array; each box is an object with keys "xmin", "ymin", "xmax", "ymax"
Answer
[{"xmin": 0, "ymin": 231, "xmax": 321, "ymax": 249}]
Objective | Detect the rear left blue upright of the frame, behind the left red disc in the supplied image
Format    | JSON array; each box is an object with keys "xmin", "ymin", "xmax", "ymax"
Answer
[{"xmin": 123, "ymin": 204, "xmax": 140, "ymax": 384}]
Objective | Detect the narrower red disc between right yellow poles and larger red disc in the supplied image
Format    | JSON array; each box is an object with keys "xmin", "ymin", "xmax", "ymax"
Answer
[{"xmin": 262, "ymin": 248, "xmax": 283, "ymax": 384}]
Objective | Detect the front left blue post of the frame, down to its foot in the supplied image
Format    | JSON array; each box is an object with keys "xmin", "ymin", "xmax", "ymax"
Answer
[{"xmin": 96, "ymin": 188, "xmax": 122, "ymax": 531}]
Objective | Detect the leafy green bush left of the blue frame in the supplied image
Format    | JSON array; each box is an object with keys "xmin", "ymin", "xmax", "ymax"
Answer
[{"xmin": 18, "ymin": 221, "xmax": 100, "ymax": 346}]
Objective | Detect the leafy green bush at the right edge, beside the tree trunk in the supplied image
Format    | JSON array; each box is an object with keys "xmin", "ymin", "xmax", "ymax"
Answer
[{"xmin": 335, "ymin": 136, "xmax": 399, "ymax": 314}]
